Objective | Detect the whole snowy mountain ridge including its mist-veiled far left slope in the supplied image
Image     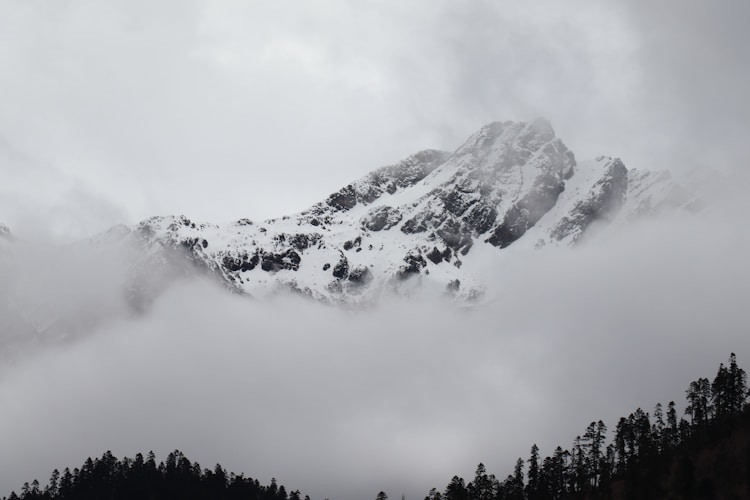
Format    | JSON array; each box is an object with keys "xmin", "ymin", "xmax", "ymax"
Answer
[{"xmin": 0, "ymin": 120, "xmax": 696, "ymax": 354}]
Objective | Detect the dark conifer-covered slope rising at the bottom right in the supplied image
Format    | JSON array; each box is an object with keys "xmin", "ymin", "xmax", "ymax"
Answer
[{"xmin": 425, "ymin": 353, "xmax": 750, "ymax": 500}]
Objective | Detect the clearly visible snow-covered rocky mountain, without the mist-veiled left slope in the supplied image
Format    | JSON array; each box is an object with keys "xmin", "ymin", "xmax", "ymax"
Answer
[{"xmin": 83, "ymin": 119, "xmax": 691, "ymax": 304}]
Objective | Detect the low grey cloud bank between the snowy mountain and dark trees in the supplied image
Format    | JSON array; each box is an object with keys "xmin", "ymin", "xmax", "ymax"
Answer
[{"xmin": 0, "ymin": 194, "xmax": 750, "ymax": 499}]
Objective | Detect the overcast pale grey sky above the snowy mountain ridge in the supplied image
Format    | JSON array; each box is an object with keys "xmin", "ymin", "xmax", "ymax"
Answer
[{"xmin": 0, "ymin": 0, "xmax": 750, "ymax": 239}]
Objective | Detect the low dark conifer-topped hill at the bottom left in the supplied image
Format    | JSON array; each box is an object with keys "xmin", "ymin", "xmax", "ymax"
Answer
[{"xmin": 3, "ymin": 451, "xmax": 309, "ymax": 500}]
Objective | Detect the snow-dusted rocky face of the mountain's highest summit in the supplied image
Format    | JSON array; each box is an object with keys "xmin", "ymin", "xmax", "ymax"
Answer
[{"xmin": 402, "ymin": 120, "xmax": 575, "ymax": 253}]
